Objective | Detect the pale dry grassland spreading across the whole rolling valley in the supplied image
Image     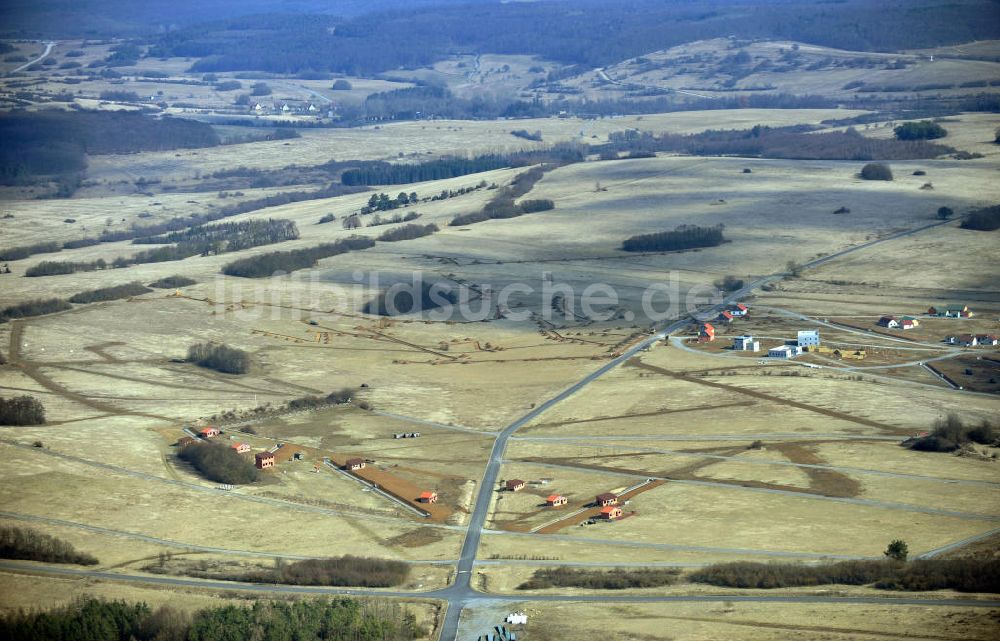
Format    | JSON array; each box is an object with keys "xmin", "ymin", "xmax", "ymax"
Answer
[{"xmin": 0, "ymin": 31, "xmax": 1000, "ymax": 641}]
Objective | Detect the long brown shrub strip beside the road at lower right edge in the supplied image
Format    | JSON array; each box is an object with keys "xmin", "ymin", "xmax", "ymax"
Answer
[{"xmin": 688, "ymin": 559, "xmax": 1000, "ymax": 592}]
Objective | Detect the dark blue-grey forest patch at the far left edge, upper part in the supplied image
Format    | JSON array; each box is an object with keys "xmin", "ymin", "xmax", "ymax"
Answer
[{"xmin": 0, "ymin": 110, "xmax": 219, "ymax": 184}]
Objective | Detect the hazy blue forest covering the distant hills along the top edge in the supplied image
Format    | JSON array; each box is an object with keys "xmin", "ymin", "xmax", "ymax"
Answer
[{"xmin": 150, "ymin": 0, "xmax": 1000, "ymax": 75}]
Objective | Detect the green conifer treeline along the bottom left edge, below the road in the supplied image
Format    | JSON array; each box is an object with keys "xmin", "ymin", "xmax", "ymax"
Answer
[{"xmin": 0, "ymin": 598, "xmax": 427, "ymax": 641}]
